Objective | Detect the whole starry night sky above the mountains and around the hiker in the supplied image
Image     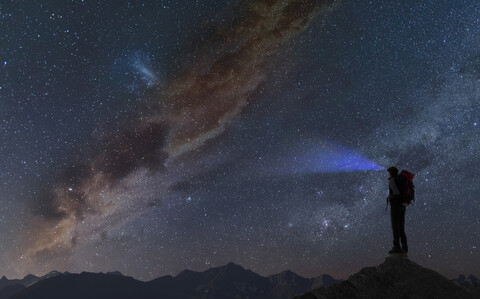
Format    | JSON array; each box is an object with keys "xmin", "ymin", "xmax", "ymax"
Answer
[{"xmin": 0, "ymin": 0, "xmax": 480, "ymax": 280}]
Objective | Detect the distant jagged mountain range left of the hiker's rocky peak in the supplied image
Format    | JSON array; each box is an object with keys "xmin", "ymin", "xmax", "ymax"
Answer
[{"xmin": 4, "ymin": 263, "xmax": 340, "ymax": 299}]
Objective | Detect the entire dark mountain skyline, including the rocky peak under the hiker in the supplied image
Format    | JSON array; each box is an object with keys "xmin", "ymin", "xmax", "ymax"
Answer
[{"xmin": 0, "ymin": 256, "xmax": 480, "ymax": 299}]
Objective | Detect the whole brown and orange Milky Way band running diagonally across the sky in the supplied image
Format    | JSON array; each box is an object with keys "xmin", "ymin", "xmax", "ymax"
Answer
[{"xmin": 21, "ymin": 0, "xmax": 335, "ymax": 272}]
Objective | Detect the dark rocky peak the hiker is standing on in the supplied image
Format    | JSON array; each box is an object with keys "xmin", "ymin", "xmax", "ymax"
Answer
[{"xmin": 295, "ymin": 257, "xmax": 480, "ymax": 299}]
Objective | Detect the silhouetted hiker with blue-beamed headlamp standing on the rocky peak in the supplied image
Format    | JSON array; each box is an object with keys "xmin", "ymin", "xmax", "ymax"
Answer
[{"xmin": 387, "ymin": 166, "xmax": 413, "ymax": 255}]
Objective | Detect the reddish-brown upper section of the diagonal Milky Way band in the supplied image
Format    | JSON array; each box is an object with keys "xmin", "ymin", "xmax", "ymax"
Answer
[{"xmin": 152, "ymin": 0, "xmax": 334, "ymax": 157}]
